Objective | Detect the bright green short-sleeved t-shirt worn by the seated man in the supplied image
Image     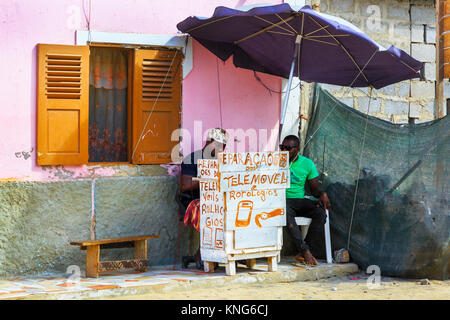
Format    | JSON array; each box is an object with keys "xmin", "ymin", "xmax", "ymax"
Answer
[{"xmin": 286, "ymin": 155, "xmax": 319, "ymax": 199}]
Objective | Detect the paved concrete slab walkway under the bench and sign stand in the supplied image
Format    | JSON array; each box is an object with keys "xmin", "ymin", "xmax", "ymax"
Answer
[{"xmin": 0, "ymin": 257, "xmax": 358, "ymax": 300}]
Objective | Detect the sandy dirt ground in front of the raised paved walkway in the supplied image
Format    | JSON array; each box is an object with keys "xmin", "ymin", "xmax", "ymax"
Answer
[{"xmin": 107, "ymin": 273, "xmax": 450, "ymax": 300}]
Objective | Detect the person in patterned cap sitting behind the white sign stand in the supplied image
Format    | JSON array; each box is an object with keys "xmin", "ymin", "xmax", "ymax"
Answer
[{"xmin": 180, "ymin": 128, "xmax": 228, "ymax": 269}]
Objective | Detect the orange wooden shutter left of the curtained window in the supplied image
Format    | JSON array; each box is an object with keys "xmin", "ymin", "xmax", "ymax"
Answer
[{"xmin": 37, "ymin": 44, "xmax": 89, "ymax": 165}]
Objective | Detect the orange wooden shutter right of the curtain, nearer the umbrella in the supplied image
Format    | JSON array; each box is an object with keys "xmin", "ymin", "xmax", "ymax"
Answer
[{"xmin": 132, "ymin": 49, "xmax": 182, "ymax": 164}]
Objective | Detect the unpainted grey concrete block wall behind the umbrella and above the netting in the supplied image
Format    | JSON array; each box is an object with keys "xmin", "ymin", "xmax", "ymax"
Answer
[{"xmin": 320, "ymin": 0, "xmax": 442, "ymax": 123}]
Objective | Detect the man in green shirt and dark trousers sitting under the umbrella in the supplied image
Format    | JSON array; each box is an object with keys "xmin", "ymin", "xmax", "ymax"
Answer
[{"xmin": 280, "ymin": 135, "xmax": 330, "ymax": 265}]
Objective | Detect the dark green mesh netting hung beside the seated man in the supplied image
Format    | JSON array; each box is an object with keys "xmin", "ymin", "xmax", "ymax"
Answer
[{"xmin": 304, "ymin": 86, "xmax": 450, "ymax": 279}]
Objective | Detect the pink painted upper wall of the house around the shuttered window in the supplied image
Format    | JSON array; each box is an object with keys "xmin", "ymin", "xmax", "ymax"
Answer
[{"xmin": 0, "ymin": 0, "xmax": 282, "ymax": 180}]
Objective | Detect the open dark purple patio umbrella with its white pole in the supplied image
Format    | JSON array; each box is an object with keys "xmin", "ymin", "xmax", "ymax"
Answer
[{"xmin": 177, "ymin": 4, "xmax": 423, "ymax": 138}]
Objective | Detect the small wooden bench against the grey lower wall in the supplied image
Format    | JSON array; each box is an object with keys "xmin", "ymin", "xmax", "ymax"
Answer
[{"xmin": 70, "ymin": 235, "xmax": 159, "ymax": 278}]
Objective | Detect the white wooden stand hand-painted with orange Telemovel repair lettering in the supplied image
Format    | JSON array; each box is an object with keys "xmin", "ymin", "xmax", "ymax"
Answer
[{"xmin": 198, "ymin": 152, "xmax": 289, "ymax": 275}]
